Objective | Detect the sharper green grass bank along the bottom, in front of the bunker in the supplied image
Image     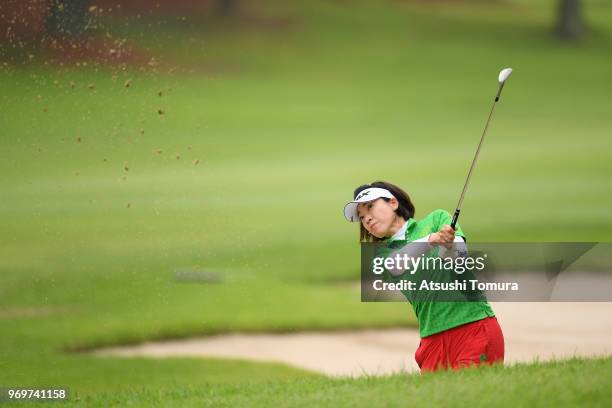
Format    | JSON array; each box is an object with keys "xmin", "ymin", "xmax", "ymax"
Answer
[{"xmin": 58, "ymin": 358, "xmax": 612, "ymax": 407}]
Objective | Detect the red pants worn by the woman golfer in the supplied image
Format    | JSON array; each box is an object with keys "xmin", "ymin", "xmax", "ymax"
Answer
[{"xmin": 414, "ymin": 317, "xmax": 504, "ymax": 371}]
